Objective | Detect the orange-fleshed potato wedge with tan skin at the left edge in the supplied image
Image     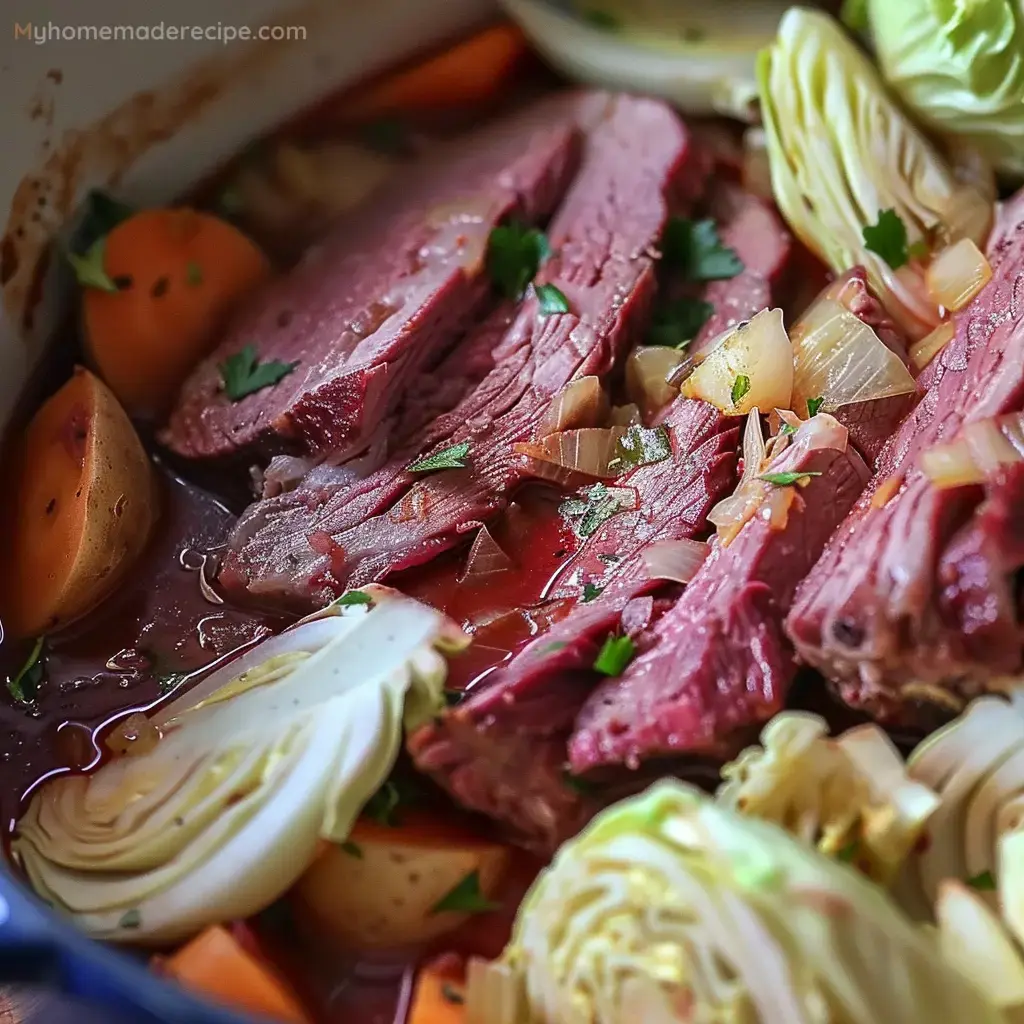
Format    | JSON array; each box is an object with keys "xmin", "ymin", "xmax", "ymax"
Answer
[{"xmin": 5, "ymin": 368, "xmax": 158, "ymax": 636}]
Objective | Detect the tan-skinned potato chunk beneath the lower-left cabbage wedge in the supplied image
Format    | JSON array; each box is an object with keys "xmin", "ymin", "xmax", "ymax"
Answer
[{"xmin": 292, "ymin": 821, "xmax": 510, "ymax": 949}]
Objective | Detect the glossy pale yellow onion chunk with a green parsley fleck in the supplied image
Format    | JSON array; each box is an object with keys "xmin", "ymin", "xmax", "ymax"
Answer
[{"xmin": 683, "ymin": 309, "xmax": 793, "ymax": 416}]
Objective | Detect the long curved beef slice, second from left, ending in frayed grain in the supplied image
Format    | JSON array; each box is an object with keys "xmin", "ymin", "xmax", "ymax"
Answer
[{"xmin": 220, "ymin": 96, "xmax": 704, "ymax": 606}]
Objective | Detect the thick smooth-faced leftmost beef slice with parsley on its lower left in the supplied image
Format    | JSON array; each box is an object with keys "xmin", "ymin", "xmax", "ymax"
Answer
[{"xmin": 161, "ymin": 98, "xmax": 586, "ymax": 458}]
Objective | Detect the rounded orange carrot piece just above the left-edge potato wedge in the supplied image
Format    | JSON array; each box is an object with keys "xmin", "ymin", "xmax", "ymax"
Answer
[{"xmin": 83, "ymin": 208, "xmax": 270, "ymax": 416}]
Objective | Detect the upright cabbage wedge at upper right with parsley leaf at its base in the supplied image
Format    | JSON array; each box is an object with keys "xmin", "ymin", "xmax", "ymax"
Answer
[{"xmin": 758, "ymin": 9, "xmax": 993, "ymax": 339}]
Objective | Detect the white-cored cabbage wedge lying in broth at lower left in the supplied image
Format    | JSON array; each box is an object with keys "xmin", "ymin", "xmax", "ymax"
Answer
[{"xmin": 13, "ymin": 597, "xmax": 460, "ymax": 943}]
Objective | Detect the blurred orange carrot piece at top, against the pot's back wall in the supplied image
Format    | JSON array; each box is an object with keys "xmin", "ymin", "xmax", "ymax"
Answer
[{"xmin": 345, "ymin": 23, "xmax": 528, "ymax": 122}]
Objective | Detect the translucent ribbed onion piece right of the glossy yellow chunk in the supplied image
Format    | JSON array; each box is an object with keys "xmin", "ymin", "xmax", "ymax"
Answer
[{"xmin": 790, "ymin": 295, "xmax": 916, "ymax": 413}]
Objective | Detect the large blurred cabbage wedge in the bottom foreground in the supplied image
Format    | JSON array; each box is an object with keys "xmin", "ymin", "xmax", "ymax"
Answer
[{"xmin": 467, "ymin": 781, "xmax": 1002, "ymax": 1024}]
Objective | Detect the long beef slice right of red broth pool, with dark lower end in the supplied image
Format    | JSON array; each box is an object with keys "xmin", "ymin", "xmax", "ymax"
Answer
[{"xmin": 410, "ymin": 398, "xmax": 737, "ymax": 851}]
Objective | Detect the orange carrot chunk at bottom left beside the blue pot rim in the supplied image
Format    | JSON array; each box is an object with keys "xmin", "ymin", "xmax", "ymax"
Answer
[{"xmin": 157, "ymin": 926, "xmax": 309, "ymax": 1024}]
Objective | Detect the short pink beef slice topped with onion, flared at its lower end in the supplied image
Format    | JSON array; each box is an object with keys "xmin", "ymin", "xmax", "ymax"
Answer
[{"xmin": 569, "ymin": 414, "xmax": 869, "ymax": 772}]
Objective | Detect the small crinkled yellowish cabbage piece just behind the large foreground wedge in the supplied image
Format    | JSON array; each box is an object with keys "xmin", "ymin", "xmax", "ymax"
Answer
[{"xmin": 717, "ymin": 712, "xmax": 939, "ymax": 884}]
